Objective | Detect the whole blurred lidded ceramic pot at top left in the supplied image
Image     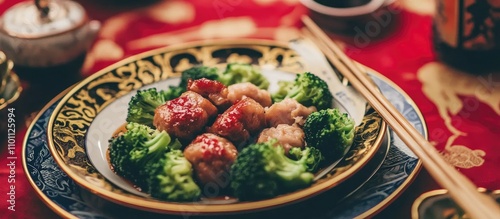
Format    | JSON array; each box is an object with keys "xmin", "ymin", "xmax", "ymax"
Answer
[{"xmin": 0, "ymin": 0, "xmax": 100, "ymax": 80}]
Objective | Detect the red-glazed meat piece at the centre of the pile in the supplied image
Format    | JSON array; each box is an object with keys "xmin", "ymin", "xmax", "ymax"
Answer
[{"xmin": 208, "ymin": 96, "xmax": 266, "ymax": 145}]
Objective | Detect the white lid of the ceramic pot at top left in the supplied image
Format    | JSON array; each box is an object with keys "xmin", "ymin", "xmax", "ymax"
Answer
[{"xmin": 0, "ymin": 0, "xmax": 87, "ymax": 38}]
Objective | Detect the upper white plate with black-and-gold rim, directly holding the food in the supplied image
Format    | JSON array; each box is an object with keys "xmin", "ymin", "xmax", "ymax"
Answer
[{"xmin": 47, "ymin": 40, "xmax": 394, "ymax": 215}]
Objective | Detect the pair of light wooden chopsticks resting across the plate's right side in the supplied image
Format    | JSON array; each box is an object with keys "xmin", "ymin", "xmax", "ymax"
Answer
[{"xmin": 302, "ymin": 16, "xmax": 500, "ymax": 219}]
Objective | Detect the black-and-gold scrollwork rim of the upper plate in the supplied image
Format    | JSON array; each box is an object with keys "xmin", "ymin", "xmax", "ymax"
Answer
[{"xmin": 47, "ymin": 39, "xmax": 386, "ymax": 214}]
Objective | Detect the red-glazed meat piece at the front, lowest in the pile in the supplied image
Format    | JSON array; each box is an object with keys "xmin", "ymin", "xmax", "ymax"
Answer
[{"xmin": 184, "ymin": 133, "xmax": 238, "ymax": 185}]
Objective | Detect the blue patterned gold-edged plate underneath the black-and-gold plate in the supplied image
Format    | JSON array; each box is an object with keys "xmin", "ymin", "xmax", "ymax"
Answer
[{"xmin": 22, "ymin": 68, "xmax": 427, "ymax": 218}]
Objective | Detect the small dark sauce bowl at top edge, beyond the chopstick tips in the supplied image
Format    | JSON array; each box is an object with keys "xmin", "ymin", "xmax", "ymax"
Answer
[{"xmin": 300, "ymin": 0, "xmax": 399, "ymax": 38}]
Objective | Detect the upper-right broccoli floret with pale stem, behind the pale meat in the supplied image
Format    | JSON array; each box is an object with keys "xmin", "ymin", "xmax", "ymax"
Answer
[{"xmin": 271, "ymin": 72, "xmax": 333, "ymax": 110}]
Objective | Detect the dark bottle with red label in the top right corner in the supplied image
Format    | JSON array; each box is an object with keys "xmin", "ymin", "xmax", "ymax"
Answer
[{"xmin": 433, "ymin": 0, "xmax": 500, "ymax": 74}]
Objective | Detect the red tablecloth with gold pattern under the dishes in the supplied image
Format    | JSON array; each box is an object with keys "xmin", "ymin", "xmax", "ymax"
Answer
[{"xmin": 0, "ymin": 0, "xmax": 500, "ymax": 218}]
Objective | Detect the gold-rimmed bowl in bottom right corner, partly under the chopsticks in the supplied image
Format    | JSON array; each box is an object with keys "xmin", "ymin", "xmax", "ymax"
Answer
[{"xmin": 411, "ymin": 188, "xmax": 500, "ymax": 219}]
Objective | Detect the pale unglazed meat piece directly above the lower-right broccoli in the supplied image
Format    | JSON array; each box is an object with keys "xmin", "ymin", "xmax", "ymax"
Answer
[{"xmin": 257, "ymin": 124, "xmax": 305, "ymax": 154}]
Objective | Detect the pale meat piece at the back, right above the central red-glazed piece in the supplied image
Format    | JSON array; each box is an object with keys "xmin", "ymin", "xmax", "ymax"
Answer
[{"xmin": 227, "ymin": 82, "xmax": 273, "ymax": 107}]
